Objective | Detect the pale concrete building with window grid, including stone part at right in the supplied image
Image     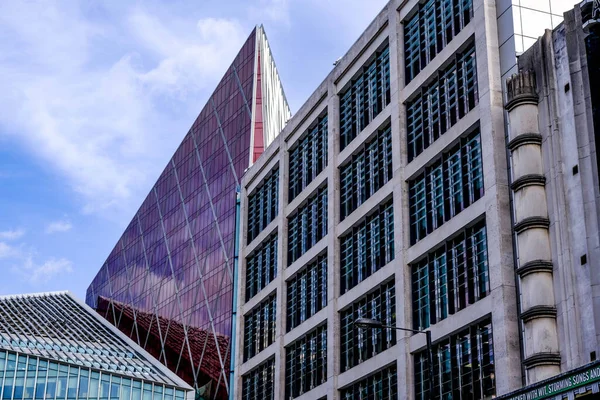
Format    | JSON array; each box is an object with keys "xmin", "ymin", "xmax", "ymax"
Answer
[{"xmin": 234, "ymin": 0, "xmax": 600, "ymax": 400}]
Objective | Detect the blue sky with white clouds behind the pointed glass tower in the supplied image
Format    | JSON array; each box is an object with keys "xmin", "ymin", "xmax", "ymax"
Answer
[{"xmin": 0, "ymin": 0, "xmax": 386, "ymax": 298}]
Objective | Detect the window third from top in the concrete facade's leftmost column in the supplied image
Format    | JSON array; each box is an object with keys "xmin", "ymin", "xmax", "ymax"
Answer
[{"xmin": 244, "ymin": 293, "xmax": 277, "ymax": 362}]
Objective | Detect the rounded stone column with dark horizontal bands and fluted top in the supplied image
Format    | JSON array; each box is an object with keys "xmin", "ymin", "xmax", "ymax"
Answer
[{"xmin": 505, "ymin": 71, "xmax": 560, "ymax": 385}]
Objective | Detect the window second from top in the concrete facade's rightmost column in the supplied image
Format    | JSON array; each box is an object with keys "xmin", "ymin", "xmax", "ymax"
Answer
[{"xmin": 406, "ymin": 44, "xmax": 479, "ymax": 162}]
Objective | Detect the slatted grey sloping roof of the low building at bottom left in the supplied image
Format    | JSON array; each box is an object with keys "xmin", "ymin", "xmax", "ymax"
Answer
[{"xmin": 0, "ymin": 292, "xmax": 191, "ymax": 390}]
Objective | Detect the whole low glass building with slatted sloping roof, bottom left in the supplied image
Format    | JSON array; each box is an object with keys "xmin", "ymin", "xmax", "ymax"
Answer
[{"xmin": 0, "ymin": 292, "xmax": 194, "ymax": 400}]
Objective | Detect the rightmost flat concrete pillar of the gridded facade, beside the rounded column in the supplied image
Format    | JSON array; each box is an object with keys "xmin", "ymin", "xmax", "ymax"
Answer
[{"xmin": 476, "ymin": 0, "xmax": 522, "ymax": 395}]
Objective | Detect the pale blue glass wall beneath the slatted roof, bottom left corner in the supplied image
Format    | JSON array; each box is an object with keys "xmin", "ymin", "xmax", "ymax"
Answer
[{"xmin": 0, "ymin": 350, "xmax": 186, "ymax": 400}]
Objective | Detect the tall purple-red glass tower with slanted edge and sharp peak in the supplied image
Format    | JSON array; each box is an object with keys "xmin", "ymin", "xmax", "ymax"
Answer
[{"xmin": 86, "ymin": 26, "xmax": 291, "ymax": 399}]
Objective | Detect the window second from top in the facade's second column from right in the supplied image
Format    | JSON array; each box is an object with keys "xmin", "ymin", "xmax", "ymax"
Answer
[{"xmin": 340, "ymin": 126, "xmax": 392, "ymax": 220}]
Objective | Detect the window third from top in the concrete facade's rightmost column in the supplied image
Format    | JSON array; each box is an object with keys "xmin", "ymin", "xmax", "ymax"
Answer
[{"xmin": 408, "ymin": 131, "xmax": 484, "ymax": 244}]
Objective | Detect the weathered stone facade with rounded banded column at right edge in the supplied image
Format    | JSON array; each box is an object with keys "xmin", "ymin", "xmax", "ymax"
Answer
[{"xmin": 507, "ymin": 2, "xmax": 600, "ymax": 394}]
